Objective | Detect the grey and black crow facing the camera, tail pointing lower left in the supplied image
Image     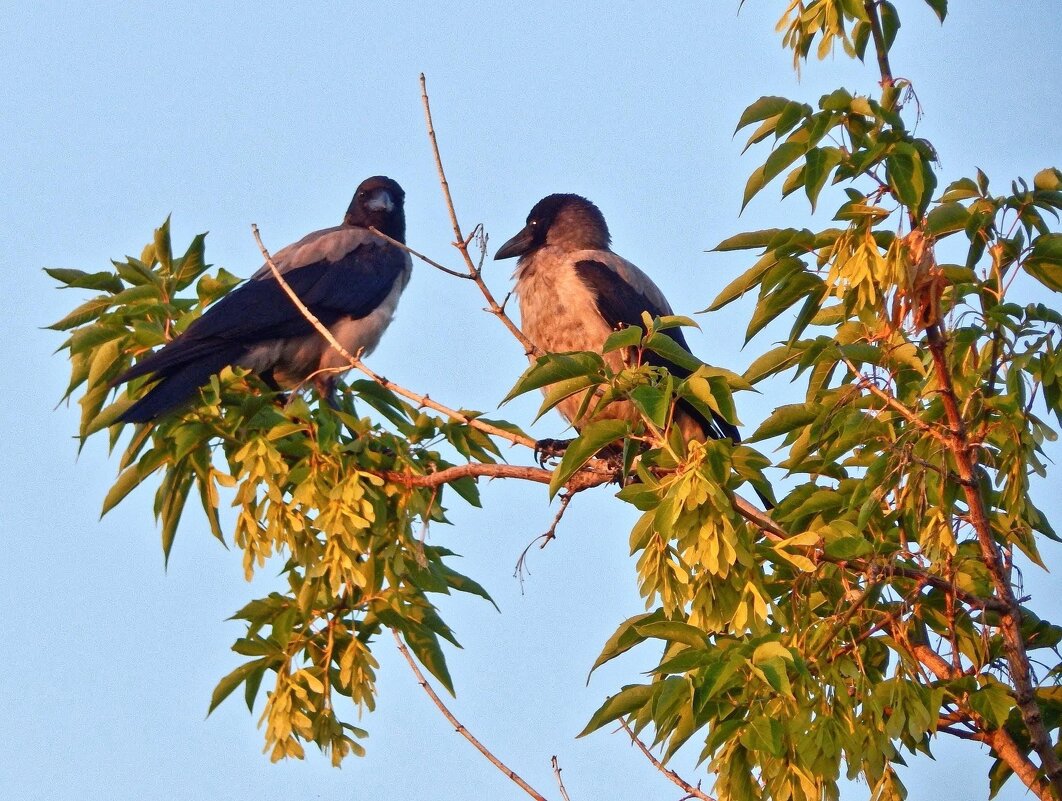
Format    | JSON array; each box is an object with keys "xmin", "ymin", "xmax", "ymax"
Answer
[{"xmin": 115, "ymin": 175, "xmax": 412, "ymax": 423}]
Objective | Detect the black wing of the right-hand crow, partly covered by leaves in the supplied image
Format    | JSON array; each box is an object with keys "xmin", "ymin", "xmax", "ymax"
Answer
[{"xmin": 575, "ymin": 259, "xmax": 741, "ymax": 442}]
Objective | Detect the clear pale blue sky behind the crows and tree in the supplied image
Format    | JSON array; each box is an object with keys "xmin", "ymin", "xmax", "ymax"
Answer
[{"xmin": 0, "ymin": 0, "xmax": 1062, "ymax": 801}]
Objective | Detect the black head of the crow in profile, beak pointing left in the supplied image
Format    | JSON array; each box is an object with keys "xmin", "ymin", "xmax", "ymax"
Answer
[{"xmin": 494, "ymin": 194, "xmax": 611, "ymax": 259}]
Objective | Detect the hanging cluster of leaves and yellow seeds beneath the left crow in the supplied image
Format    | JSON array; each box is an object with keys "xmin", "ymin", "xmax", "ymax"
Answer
[{"xmin": 48, "ymin": 220, "xmax": 508, "ymax": 764}]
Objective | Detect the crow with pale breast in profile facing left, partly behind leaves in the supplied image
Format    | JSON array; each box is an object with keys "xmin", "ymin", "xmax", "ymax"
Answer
[{"xmin": 494, "ymin": 194, "xmax": 767, "ymax": 502}]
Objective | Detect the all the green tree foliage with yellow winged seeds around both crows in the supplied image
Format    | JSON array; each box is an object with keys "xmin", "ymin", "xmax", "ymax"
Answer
[{"xmin": 50, "ymin": 0, "xmax": 1062, "ymax": 801}]
